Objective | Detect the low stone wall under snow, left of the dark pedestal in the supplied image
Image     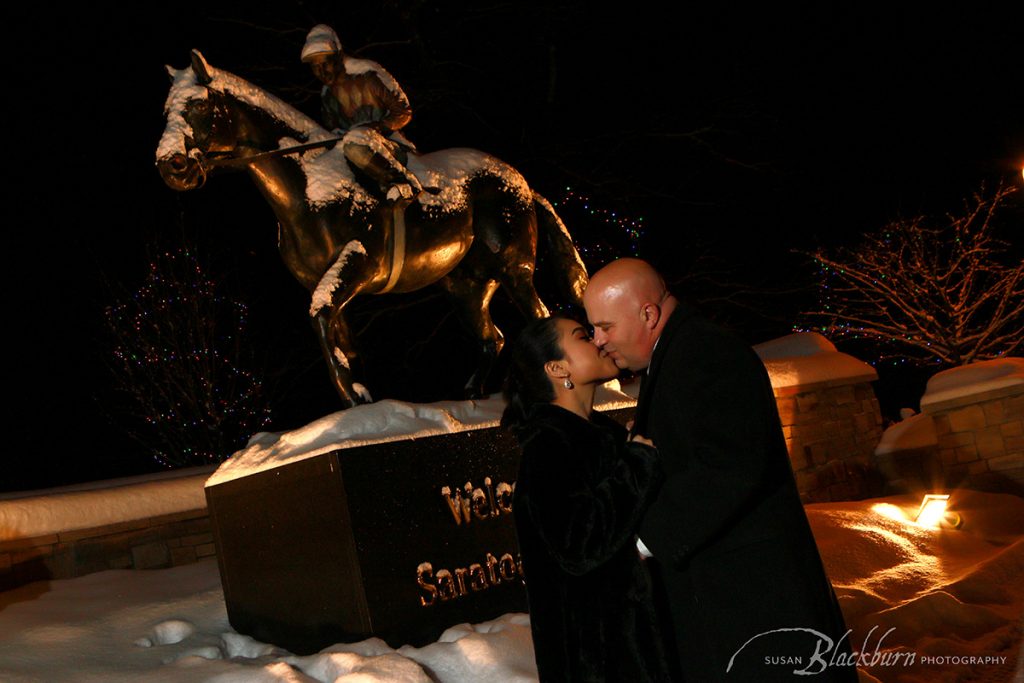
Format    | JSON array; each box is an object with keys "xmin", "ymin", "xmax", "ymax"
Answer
[{"xmin": 0, "ymin": 508, "xmax": 216, "ymax": 590}]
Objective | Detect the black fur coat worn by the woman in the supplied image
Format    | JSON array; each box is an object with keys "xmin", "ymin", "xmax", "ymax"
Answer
[{"xmin": 513, "ymin": 404, "xmax": 669, "ymax": 681}]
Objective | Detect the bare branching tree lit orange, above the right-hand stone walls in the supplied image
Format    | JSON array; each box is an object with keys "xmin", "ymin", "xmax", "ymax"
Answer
[{"xmin": 805, "ymin": 180, "xmax": 1024, "ymax": 366}]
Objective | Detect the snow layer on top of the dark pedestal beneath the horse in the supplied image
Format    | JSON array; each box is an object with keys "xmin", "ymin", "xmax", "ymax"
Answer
[{"xmin": 206, "ymin": 380, "xmax": 636, "ymax": 486}]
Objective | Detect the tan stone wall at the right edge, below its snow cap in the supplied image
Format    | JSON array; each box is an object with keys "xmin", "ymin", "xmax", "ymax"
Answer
[{"xmin": 922, "ymin": 384, "xmax": 1024, "ymax": 495}]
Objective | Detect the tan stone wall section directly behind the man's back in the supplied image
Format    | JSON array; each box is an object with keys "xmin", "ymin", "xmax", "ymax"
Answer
[{"xmin": 774, "ymin": 375, "xmax": 882, "ymax": 503}]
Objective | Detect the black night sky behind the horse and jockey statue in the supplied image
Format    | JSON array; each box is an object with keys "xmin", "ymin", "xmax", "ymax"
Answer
[{"xmin": 0, "ymin": 1, "xmax": 1024, "ymax": 490}]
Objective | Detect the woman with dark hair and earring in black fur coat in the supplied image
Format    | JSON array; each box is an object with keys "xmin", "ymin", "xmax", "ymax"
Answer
[{"xmin": 502, "ymin": 317, "xmax": 670, "ymax": 681}]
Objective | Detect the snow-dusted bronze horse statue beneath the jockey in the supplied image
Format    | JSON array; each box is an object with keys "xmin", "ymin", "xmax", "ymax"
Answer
[{"xmin": 157, "ymin": 50, "xmax": 587, "ymax": 408}]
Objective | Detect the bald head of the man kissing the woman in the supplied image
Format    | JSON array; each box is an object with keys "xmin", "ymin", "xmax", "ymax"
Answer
[{"xmin": 583, "ymin": 258, "xmax": 676, "ymax": 372}]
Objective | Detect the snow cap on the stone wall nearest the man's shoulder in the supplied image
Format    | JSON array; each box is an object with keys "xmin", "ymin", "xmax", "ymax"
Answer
[{"xmin": 754, "ymin": 332, "xmax": 878, "ymax": 389}]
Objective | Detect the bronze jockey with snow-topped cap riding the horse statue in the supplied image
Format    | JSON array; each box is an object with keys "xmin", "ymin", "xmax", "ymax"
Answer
[{"xmin": 302, "ymin": 24, "xmax": 423, "ymax": 207}]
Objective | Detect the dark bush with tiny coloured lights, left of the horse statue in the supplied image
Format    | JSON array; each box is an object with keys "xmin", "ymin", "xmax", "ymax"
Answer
[{"xmin": 105, "ymin": 249, "xmax": 269, "ymax": 468}]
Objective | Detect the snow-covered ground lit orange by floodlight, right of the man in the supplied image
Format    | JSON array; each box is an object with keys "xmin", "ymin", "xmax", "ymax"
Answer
[{"xmin": 807, "ymin": 490, "xmax": 1024, "ymax": 683}]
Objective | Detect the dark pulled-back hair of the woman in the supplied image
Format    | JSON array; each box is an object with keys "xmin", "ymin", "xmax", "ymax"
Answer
[{"xmin": 502, "ymin": 316, "xmax": 565, "ymax": 429}]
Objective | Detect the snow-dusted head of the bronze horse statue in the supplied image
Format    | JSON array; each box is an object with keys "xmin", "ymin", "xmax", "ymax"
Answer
[{"xmin": 157, "ymin": 50, "xmax": 247, "ymax": 190}]
